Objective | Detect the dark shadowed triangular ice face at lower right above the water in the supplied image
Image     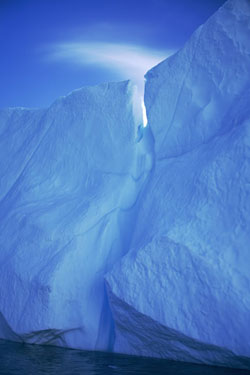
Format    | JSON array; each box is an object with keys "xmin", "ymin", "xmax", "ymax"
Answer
[{"xmin": 106, "ymin": 281, "xmax": 250, "ymax": 369}]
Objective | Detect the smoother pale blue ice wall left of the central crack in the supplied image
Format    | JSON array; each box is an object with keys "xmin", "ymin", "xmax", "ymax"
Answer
[{"xmin": 0, "ymin": 82, "xmax": 150, "ymax": 349}]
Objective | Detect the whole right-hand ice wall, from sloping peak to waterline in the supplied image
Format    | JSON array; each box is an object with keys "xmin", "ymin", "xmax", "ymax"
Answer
[{"xmin": 107, "ymin": 0, "xmax": 250, "ymax": 366}]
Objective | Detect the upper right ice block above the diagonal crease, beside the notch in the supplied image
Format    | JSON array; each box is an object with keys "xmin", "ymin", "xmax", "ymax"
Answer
[{"xmin": 145, "ymin": 0, "xmax": 250, "ymax": 159}]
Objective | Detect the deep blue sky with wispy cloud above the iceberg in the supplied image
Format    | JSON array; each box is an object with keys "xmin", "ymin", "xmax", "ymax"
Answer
[{"xmin": 0, "ymin": 0, "xmax": 225, "ymax": 108}]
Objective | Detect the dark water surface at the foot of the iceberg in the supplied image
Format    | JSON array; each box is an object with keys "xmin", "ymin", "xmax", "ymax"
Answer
[{"xmin": 0, "ymin": 340, "xmax": 250, "ymax": 375}]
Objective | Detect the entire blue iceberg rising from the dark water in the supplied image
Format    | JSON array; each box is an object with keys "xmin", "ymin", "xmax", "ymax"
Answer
[{"xmin": 0, "ymin": 0, "xmax": 250, "ymax": 368}]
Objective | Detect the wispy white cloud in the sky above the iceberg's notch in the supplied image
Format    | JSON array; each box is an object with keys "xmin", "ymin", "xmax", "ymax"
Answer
[{"xmin": 44, "ymin": 42, "xmax": 174, "ymax": 90}]
